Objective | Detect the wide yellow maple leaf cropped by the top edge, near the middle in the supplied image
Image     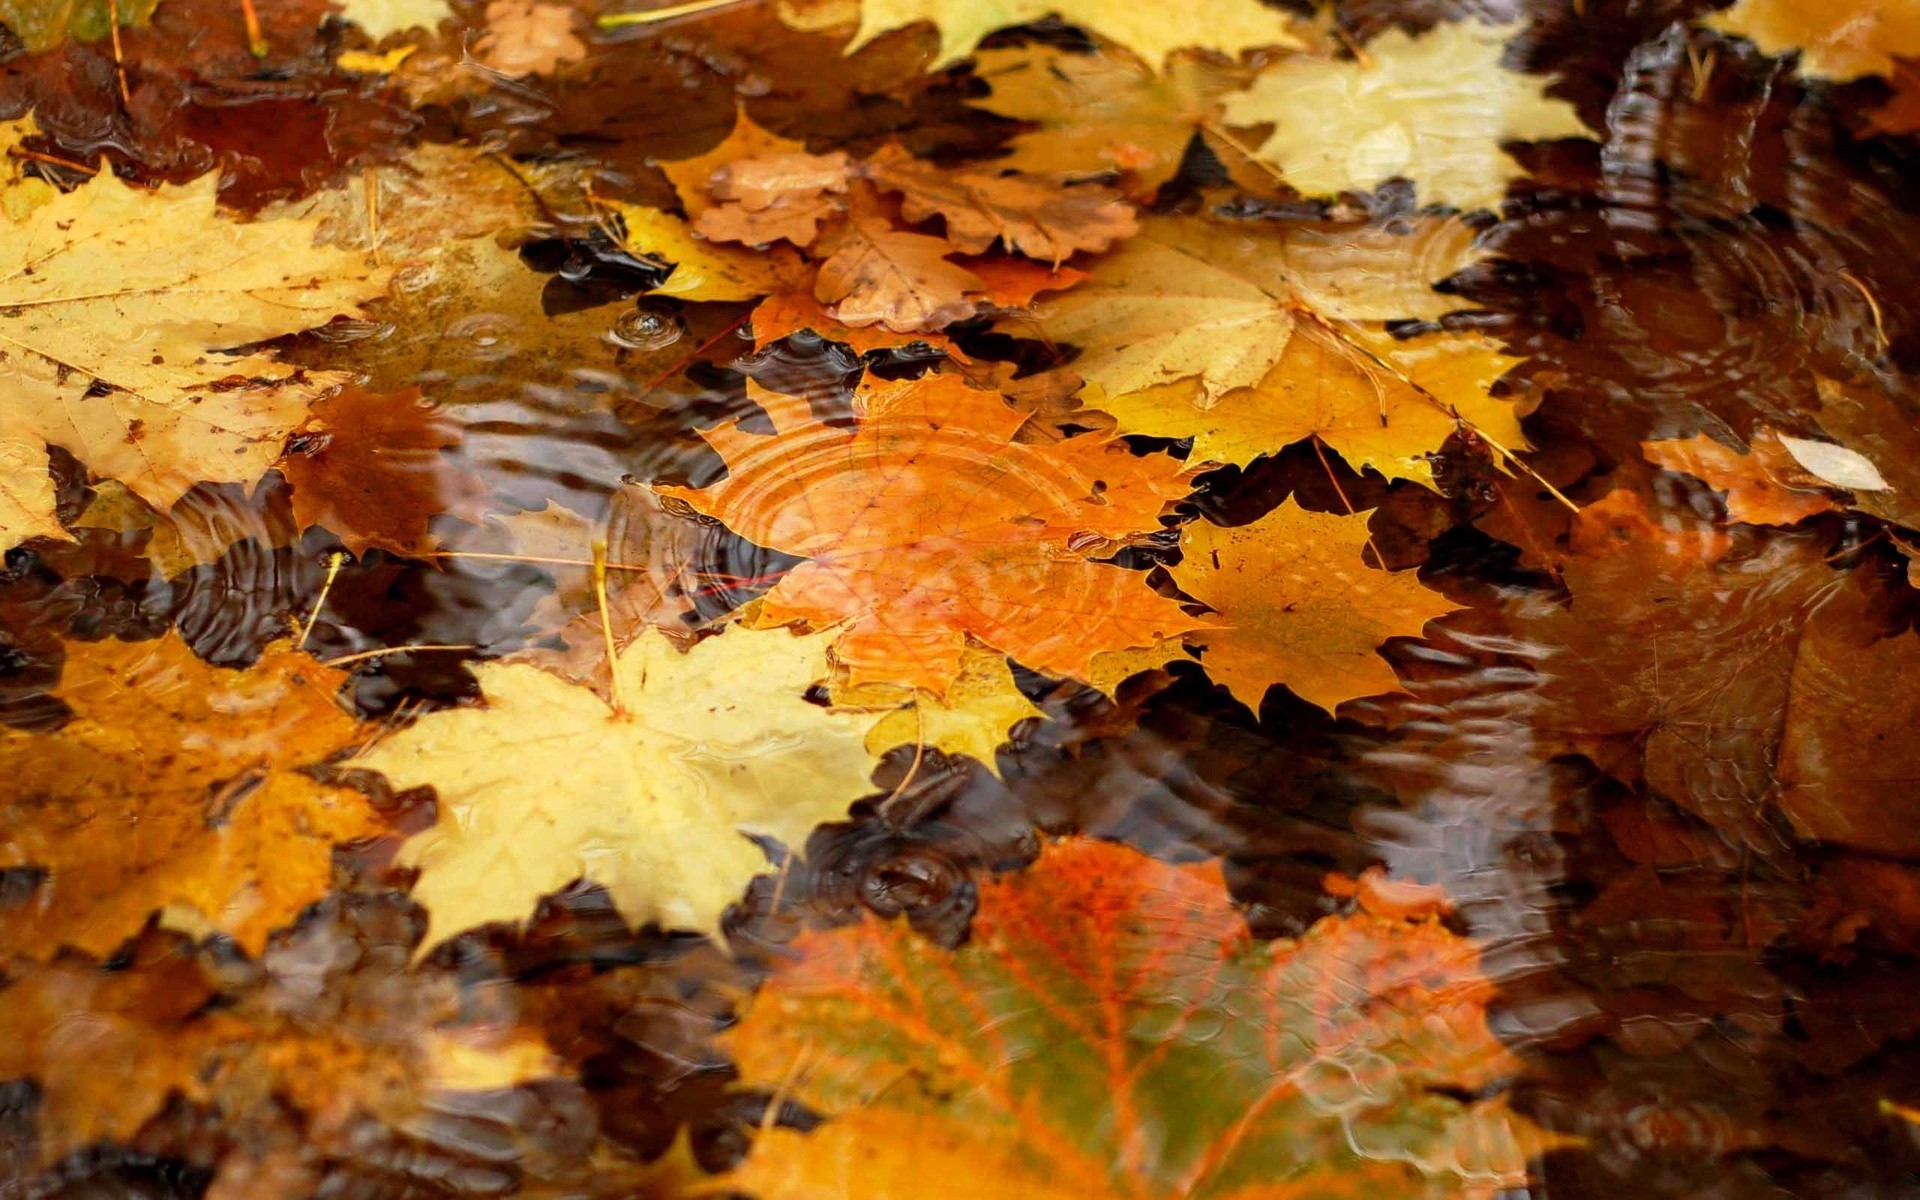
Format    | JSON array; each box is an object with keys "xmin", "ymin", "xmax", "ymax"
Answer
[{"xmin": 810, "ymin": 0, "xmax": 1300, "ymax": 71}]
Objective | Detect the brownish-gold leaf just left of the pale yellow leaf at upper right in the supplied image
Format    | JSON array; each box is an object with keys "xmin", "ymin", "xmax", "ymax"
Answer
[{"xmin": 968, "ymin": 44, "xmax": 1235, "ymax": 196}]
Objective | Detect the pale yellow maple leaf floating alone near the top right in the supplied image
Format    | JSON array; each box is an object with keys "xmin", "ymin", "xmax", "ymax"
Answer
[{"xmin": 1223, "ymin": 21, "xmax": 1590, "ymax": 209}]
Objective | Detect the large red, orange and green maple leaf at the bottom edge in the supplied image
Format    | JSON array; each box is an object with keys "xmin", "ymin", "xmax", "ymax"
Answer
[{"xmin": 722, "ymin": 841, "xmax": 1565, "ymax": 1200}]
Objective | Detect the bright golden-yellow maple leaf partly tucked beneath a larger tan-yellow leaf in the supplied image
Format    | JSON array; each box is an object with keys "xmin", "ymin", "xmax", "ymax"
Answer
[{"xmin": 1087, "ymin": 324, "xmax": 1528, "ymax": 488}]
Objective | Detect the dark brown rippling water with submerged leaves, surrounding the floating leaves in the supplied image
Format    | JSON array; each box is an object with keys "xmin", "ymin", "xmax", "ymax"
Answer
[{"xmin": 0, "ymin": 0, "xmax": 1920, "ymax": 1200}]
